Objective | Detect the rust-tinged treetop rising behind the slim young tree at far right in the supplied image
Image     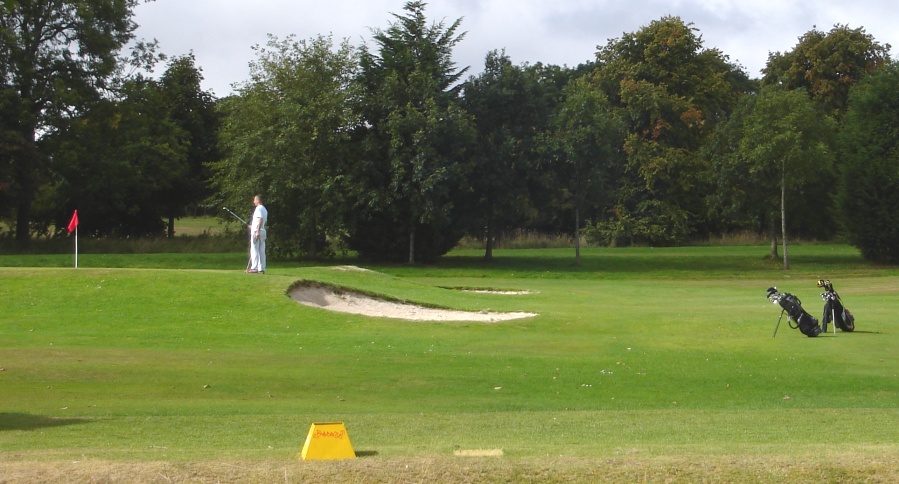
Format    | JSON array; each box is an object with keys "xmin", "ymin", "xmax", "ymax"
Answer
[{"xmin": 762, "ymin": 24, "xmax": 890, "ymax": 119}]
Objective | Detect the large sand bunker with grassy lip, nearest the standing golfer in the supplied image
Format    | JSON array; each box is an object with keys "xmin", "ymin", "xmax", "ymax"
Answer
[{"xmin": 288, "ymin": 285, "xmax": 536, "ymax": 323}]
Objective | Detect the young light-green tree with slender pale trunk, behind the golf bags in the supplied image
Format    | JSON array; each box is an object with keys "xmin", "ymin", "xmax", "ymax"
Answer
[{"xmin": 705, "ymin": 86, "xmax": 836, "ymax": 253}]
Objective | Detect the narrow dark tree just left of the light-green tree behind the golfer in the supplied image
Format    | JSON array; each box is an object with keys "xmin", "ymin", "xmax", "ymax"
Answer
[{"xmin": 160, "ymin": 53, "xmax": 220, "ymax": 238}]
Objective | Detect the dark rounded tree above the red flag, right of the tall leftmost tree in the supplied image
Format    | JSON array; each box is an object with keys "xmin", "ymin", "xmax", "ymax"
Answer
[{"xmin": 50, "ymin": 79, "xmax": 188, "ymax": 237}]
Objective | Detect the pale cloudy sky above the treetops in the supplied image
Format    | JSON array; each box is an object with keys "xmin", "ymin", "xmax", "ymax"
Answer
[{"xmin": 135, "ymin": 0, "xmax": 899, "ymax": 97}]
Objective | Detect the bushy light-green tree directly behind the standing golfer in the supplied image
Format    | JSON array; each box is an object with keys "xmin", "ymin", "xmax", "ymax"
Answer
[{"xmin": 212, "ymin": 36, "xmax": 359, "ymax": 257}]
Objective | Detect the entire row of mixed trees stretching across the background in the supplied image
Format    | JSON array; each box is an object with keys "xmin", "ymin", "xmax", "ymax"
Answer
[{"xmin": 0, "ymin": 0, "xmax": 899, "ymax": 267}]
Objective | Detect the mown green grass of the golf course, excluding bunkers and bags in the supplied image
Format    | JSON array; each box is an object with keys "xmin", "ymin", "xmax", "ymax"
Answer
[{"xmin": 0, "ymin": 245, "xmax": 899, "ymax": 482}]
